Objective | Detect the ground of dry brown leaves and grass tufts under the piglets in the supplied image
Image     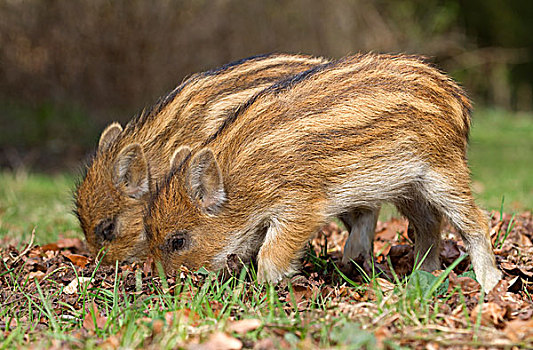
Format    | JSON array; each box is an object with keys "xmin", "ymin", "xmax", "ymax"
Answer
[{"xmin": 0, "ymin": 212, "xmax": 533, "ymax": 349}]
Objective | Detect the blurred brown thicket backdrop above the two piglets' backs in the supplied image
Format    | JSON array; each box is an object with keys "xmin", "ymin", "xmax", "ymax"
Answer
[{"xmin": 0, "ymin": 0, "xmax": 531, "ymax": 170}]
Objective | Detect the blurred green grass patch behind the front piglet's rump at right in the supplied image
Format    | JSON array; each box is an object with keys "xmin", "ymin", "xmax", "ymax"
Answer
[{"xmin": 468, "ymin": 110, "xmax": 533, "ymax": 210}]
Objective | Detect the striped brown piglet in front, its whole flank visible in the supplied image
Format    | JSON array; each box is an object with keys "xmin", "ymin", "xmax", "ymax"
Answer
[{"xmin": 145, "ymin": 54, "xmax": 501, "ymax": 290}]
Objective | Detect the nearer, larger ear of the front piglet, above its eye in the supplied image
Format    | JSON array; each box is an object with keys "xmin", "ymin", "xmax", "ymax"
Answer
[{"xmin": 185, "ymin": 148, "xmax": 226, "ymax": 214}]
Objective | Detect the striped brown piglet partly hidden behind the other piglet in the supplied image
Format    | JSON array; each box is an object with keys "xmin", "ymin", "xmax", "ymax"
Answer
[{"xmin": 75, "ymin": 54, "xmax": 326, "ymax": 263}]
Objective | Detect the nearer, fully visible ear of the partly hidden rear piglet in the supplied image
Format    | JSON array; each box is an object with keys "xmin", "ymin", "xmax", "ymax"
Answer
[{"xmin": 113, "ymin": 143, "xmax": 150, "ymax": 199}]
